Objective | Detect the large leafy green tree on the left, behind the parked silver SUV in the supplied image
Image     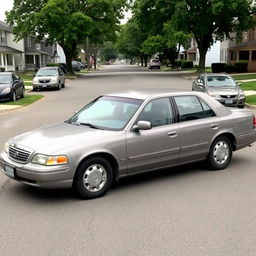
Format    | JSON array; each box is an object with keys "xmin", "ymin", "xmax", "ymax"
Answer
[{"xmin": 7, "ymin": 0, "xmax": 126, "ymax": 72}]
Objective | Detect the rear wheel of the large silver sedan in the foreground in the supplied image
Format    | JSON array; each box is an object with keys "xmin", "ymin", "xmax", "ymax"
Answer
[{"xmin": 208, "ymin": 136, "xmax": 233, "ymax": 170}]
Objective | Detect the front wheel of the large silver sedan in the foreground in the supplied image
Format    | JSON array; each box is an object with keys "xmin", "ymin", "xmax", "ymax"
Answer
[{"xmin": 73, "ymin": 157, "xmax": 113, "ymax": 199}]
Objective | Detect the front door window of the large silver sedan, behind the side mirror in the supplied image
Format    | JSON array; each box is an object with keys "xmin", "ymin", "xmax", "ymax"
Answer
[{"xmin": 137, "ymin": 98, "xmax": 173, "ymax": 127}]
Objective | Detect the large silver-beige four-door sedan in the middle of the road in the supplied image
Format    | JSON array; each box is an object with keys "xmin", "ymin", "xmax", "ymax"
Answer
[{"xmin": 0, "ymin": 90, "xmax": 256, "ymax": 199}]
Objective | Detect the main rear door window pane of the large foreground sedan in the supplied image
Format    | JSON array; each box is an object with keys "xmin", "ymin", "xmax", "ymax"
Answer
[{"xmin": 174, "ymin": 96, "xmax": 205, "ymax": 122}]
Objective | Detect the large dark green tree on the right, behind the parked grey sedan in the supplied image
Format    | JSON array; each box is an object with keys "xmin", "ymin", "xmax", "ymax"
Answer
[{"xmin": 172, "ymin": 0, "xmax": 255, "ymax": 72}]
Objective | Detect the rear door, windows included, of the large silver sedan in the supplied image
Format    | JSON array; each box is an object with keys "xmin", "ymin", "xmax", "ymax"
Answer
[{"xmin": 174, "ymin": 95, "xmax": 219, "ymax": 163}]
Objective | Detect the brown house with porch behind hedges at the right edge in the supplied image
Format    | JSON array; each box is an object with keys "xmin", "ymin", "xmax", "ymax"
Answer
[{"xmin": 220, "ymin": 29, "xmax": 256, "ymax": 72}]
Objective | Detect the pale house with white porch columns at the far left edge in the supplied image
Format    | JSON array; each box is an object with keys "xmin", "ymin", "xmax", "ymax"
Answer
[{"xmin": 0, "ymin": 21, "xmax": 24, "ymax": 71}]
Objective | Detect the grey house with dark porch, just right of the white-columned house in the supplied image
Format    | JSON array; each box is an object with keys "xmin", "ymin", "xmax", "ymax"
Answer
[{"xmin": 24, "ymin": 36, "xmax": 59, "ymax": 70}]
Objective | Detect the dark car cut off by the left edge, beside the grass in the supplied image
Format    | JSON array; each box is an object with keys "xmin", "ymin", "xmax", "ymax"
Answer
[{"xmin": 0, "ymin": 72, "xmax": 25, "ymax": 101}]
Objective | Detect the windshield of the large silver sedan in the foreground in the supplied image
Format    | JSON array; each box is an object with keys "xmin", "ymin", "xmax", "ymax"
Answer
[{"xmin": 67, "ymin": 96, "xmax": 142, "ymax": 131}]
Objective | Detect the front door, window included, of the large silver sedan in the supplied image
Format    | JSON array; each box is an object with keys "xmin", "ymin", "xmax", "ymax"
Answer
[{"xmin": 126, "ymin": 98, "xmax": 180, "ymax": 173}]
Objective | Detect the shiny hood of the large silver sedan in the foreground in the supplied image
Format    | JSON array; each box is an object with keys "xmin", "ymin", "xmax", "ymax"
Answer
[{"xmin": 9, "ymin": 122, "xmax": 119, "ymax": 154}]
